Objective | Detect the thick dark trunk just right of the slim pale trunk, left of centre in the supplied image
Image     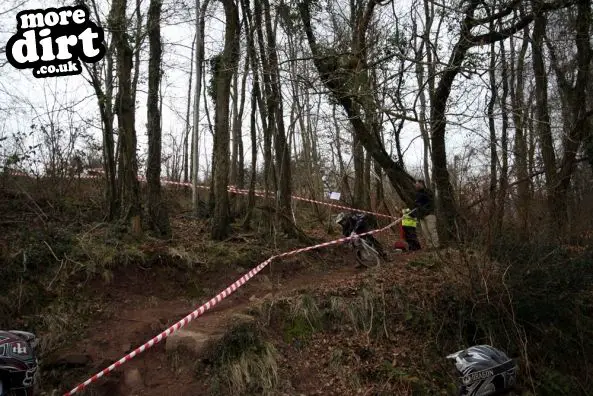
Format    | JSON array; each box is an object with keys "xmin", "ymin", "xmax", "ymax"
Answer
[{"xmin": 212, "ymin": 0, "xmax": 240, "ymax": 240}]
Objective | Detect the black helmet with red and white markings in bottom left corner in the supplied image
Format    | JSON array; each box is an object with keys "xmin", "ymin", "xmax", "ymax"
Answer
[{"xmin": 0, "ymin": 330, "xmax": 37, "ymax": 396}]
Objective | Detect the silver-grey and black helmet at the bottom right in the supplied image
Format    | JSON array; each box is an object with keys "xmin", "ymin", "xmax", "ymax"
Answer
[{"xmin": 447, "ymin": 345, "xmax": 517, "ymax": 396}]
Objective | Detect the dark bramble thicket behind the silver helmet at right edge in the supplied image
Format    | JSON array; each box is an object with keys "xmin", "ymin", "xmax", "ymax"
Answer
[{"xmin": 415, "ymin": 238, "xmax": 593, "ymax": 395}]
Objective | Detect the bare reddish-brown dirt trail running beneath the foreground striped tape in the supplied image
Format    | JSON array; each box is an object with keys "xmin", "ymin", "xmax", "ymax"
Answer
[{"xmin": 55, "ymin": 240, "xmax": 404, "ymax": 396}]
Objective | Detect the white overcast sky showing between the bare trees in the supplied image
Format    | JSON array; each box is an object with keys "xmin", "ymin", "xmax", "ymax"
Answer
[{"xmin": 0, "ymin": 0, "xmax": 488, "ymax": 183}]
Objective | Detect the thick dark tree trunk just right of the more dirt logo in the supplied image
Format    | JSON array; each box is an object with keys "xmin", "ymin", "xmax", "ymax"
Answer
[{"xmin": 111, "ymin": 0, "xmax": 142, "ymax": 234}]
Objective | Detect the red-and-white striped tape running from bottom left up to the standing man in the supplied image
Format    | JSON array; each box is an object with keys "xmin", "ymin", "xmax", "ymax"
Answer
[{"xmin": 64, "ymin": 218, "xmax": 402, "ymax": 396}]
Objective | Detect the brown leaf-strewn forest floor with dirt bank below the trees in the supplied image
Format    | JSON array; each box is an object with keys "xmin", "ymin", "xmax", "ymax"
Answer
[{"xmin": 0, "ymin": 178, "xmax": 593, "ymax": 396}]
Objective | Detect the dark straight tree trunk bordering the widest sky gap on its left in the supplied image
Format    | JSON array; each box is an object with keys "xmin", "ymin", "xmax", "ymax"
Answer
[{"xmin": 146, "ymin": 0, "xmax": 171, "ymax": 237}]
